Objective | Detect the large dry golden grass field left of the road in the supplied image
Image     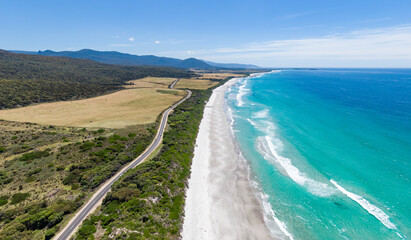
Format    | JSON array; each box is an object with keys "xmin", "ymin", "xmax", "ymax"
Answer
[{"xmin": 0, "ymin": 88, "xmax": 185, "ymax": 128}]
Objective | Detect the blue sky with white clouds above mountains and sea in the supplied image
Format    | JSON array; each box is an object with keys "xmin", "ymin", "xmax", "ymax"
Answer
[{"xmin": 0, "ymin": 0, "xmax": 411, "ymax": 68}]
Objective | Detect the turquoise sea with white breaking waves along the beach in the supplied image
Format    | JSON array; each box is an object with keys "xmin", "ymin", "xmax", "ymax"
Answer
[{"xmin": 227, "ymin": 69, "xmax": 411, "ymax": 239}]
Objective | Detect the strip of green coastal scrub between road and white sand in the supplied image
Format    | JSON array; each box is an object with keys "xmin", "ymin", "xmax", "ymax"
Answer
[{"xmin": 76, "ymin": 81, "xmax": 229, "ymax": 239}]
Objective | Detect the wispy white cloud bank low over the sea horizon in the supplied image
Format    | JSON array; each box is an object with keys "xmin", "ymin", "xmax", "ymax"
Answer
[{"xmin": 191, "ymin": 25, "xmax": 411, "ymax": 67}]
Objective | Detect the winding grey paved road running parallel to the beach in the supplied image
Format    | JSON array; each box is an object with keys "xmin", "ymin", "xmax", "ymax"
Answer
[{"xmin": 54, "ymin": 79, "xmax": 191, "ymax": 240}]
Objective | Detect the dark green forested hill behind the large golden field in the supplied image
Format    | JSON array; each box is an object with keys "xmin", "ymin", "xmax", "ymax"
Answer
[{"xmin": 0, "ymin": 50, "xmax": 193, "ymax": 109}]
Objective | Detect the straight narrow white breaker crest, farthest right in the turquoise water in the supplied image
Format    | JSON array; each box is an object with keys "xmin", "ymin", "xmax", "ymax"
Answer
[{"xmin": 330, "ymin": 179, "xmax": 397, "ymax": 229}]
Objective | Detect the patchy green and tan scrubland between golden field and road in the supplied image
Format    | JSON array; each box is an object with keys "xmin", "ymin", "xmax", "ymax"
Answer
[{"xmin": 0, "ymin": 120, "xmax": 157, "ymax": 240}]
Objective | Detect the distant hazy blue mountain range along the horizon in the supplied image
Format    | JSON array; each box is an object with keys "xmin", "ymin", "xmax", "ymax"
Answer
[{"xmin": 11, "ymin": 49, "xmax": 258, "ymax": 69}]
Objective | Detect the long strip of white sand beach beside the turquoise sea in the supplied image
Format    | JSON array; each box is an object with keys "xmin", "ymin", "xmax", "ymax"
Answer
[{"xmin": 182, "ymin": 79, "xmax": 273, "ymax": 240}]
